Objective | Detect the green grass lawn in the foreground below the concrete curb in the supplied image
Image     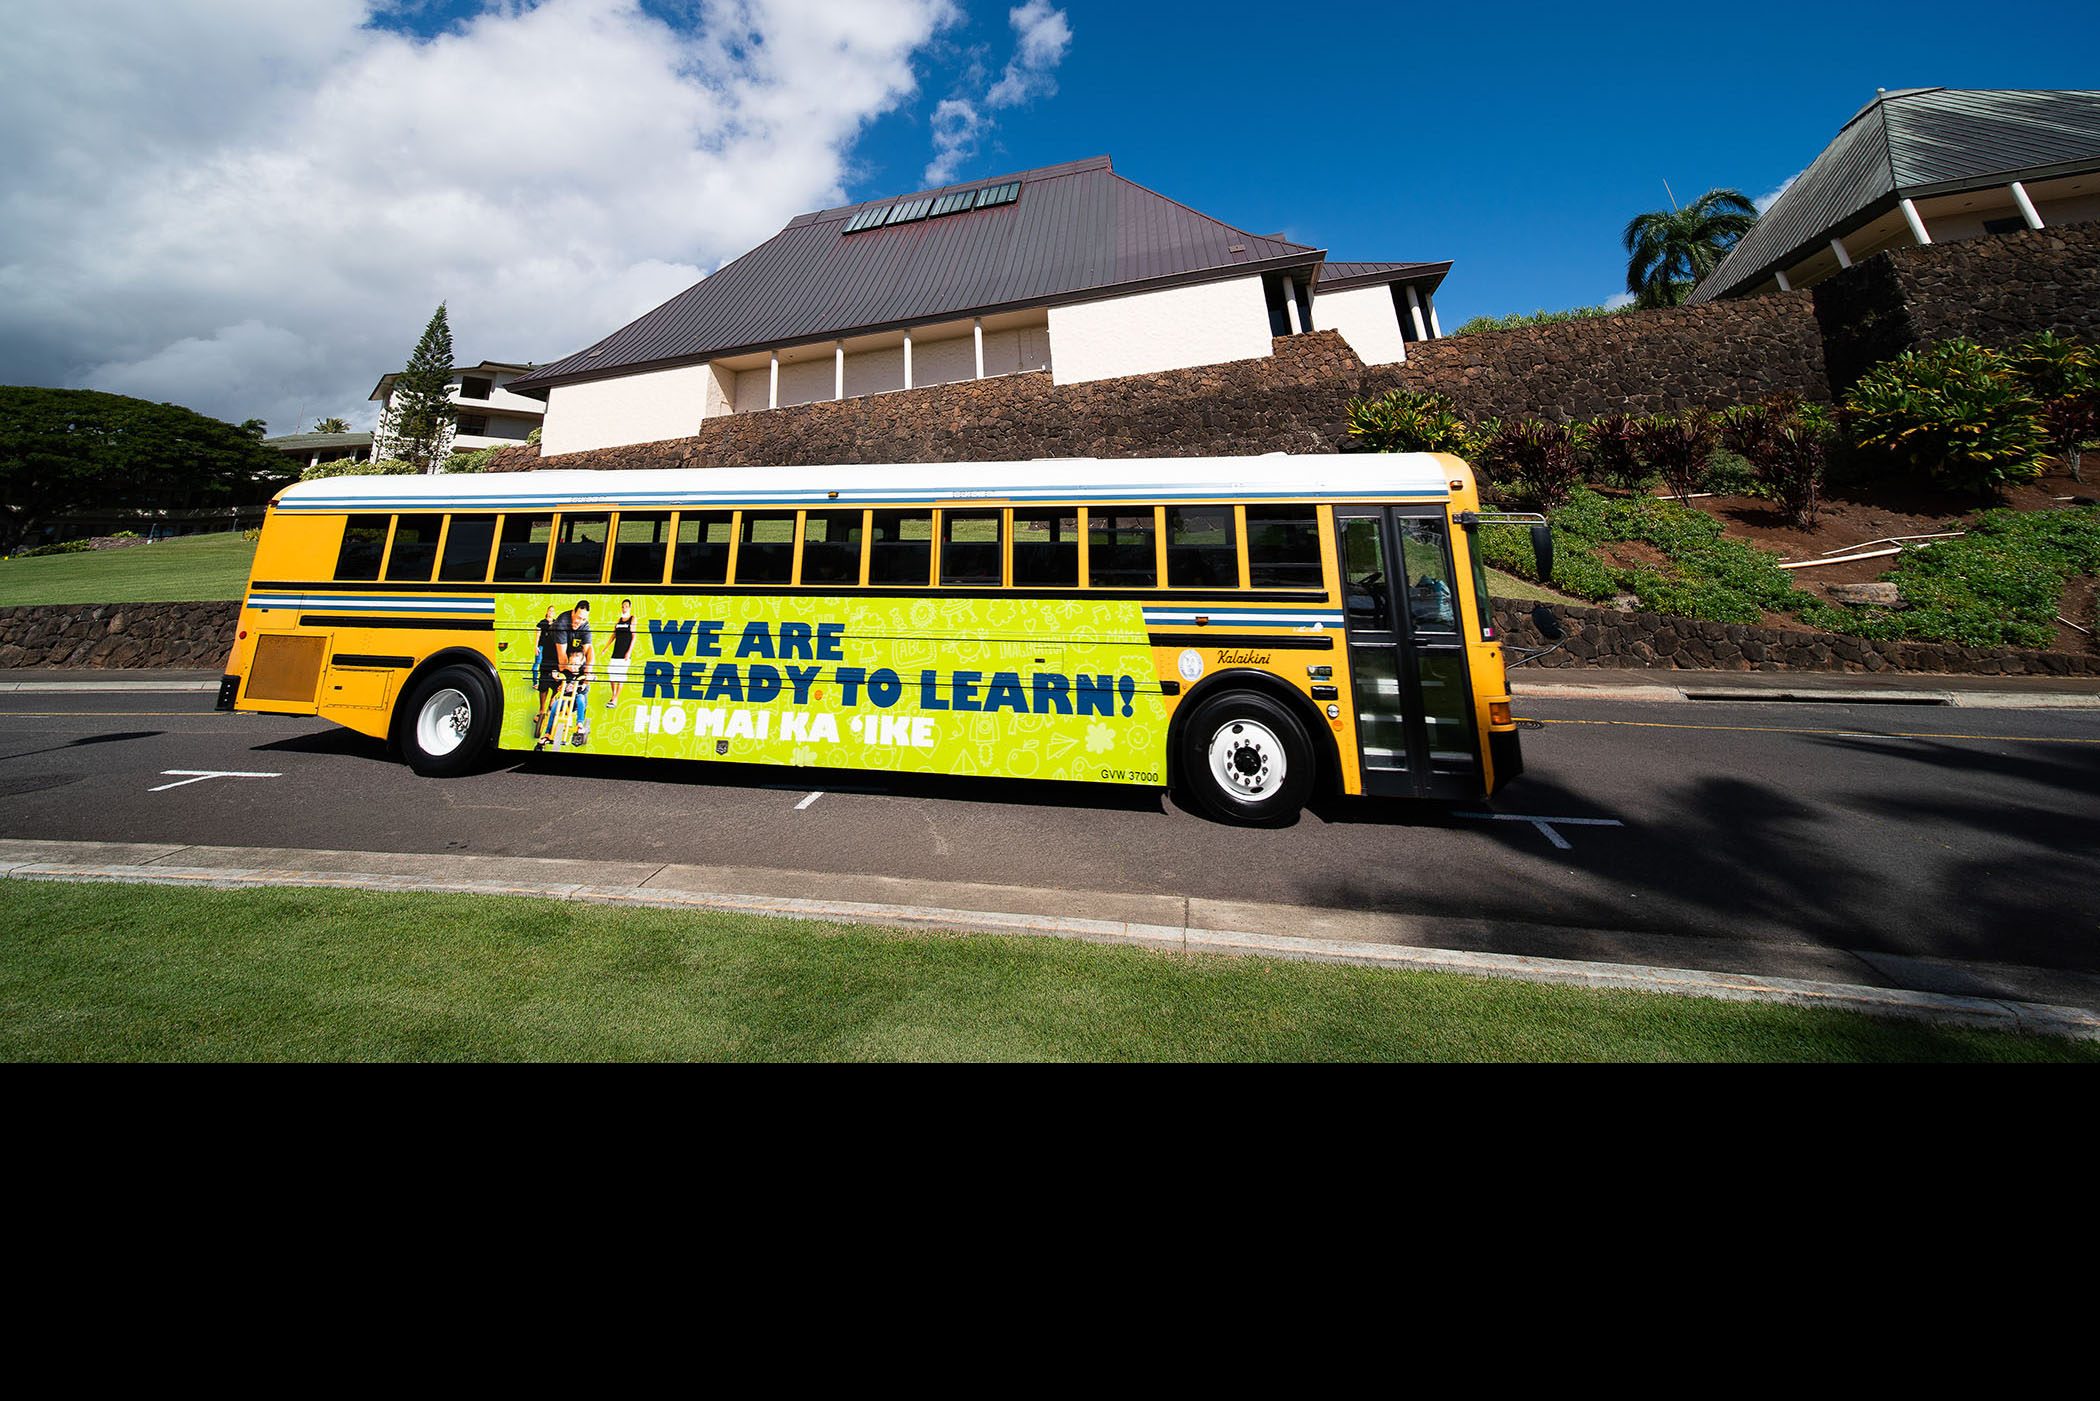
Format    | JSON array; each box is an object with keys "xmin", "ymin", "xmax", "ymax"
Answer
[{"xmin": 0, "ymin": 880, "xmax": 2100, "ymax": 1063}]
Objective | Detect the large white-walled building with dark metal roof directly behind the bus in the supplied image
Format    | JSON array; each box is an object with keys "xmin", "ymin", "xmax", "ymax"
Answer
[{"xmin": 506, "ymin": 155, "xmax": 1451, "ymax": 456}]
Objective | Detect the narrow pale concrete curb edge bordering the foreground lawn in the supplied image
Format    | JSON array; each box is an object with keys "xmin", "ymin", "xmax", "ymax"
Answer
[{"xmin": 0, "ymin": 861, "xmax": 2100, "ymax": 1042}]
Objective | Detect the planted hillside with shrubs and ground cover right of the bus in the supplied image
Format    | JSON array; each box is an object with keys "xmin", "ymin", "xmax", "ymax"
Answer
[{"xmin": 1350, "ymin": 334, "xmax": 2100, "ymax": 653}]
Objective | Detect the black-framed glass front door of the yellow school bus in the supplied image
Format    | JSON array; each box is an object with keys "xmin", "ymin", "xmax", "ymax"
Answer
[{"xmin": 1334, "ymin": 506, "xmax": 1481, "ymax": 798}]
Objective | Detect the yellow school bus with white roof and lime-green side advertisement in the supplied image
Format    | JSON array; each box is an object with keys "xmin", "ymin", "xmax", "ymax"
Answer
[{"xmin": 218, "ymin": 454, "xmax": 1535, "ymax": 823}]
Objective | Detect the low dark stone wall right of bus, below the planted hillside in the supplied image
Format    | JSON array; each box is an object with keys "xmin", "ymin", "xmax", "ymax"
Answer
[{"xmin": 1495, "ymin": 601, "xmax": 2100, "ymax": 676}]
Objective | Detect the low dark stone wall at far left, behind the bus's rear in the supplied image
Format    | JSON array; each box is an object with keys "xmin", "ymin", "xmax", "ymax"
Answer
[{"xmin": 0, "ymin": 603, "xmax": 242, "ymax": 670}]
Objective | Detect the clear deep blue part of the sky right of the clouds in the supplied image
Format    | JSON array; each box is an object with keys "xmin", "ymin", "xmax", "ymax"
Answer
[{"xmin": 823, "ymin": 0, "xmax": 2100, "ymax": 328}]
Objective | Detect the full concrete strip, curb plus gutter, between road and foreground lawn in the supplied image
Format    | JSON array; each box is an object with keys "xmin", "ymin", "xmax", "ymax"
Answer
[{"xmin": 0, "ymin": 838, "xmax": 2100, "ymax": 1040}]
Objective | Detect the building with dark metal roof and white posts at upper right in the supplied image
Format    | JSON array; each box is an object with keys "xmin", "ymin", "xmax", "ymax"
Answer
[{"xmin": 1688, "ymin": 88, "xmax": 2100, "ymax": 302}]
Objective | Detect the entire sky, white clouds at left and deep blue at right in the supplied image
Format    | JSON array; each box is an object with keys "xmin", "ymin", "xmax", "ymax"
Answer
[{"xmin": 0, "ymin": 0, "xmax": 2100, "ymax": 433}]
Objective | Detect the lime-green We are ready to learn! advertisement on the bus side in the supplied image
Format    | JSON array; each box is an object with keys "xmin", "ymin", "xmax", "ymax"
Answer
[{"xmin": 496, "ymin": 592, "xmax": 1168, "ymax": 786}]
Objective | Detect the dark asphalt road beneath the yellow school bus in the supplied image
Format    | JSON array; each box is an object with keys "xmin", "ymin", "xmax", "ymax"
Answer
[{"xmin": 0, "ymin": 691, "xmax": 2100, "ymax": 989}]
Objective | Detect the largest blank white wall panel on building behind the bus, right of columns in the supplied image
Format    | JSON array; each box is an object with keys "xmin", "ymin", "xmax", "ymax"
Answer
[{"xmin": 1045, "ymin": 277, "xmax": 1273, "ymax": 384}]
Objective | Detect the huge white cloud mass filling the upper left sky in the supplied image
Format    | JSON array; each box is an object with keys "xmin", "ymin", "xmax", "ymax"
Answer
[{"xmin": 0, "ymin": 0, "xmax": 958, "ymax": 433}]
